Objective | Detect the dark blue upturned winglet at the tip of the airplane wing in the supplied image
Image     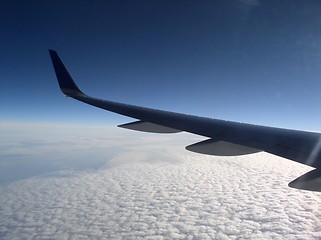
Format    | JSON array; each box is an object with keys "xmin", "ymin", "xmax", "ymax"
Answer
[{"xmin": 49, "ymin": 49, "xmax": 84, "ymax": 97}]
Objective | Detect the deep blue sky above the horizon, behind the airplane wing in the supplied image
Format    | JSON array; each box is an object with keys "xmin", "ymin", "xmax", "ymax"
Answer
[{"xmin": 0, "ymin": 0, "xmax": 321, "ymax": 131}]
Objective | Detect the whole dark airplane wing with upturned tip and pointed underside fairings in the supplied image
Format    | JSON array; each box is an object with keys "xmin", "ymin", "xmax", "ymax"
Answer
[{"xmin": 49, "ymin": 50, "xmax": 321, "ymax": 192}]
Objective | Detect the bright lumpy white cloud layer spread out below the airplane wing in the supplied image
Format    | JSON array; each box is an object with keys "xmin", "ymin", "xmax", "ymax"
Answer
[{"xmin": 0, "ymin": 123, "xmax": 321, "ymax": 239}]
